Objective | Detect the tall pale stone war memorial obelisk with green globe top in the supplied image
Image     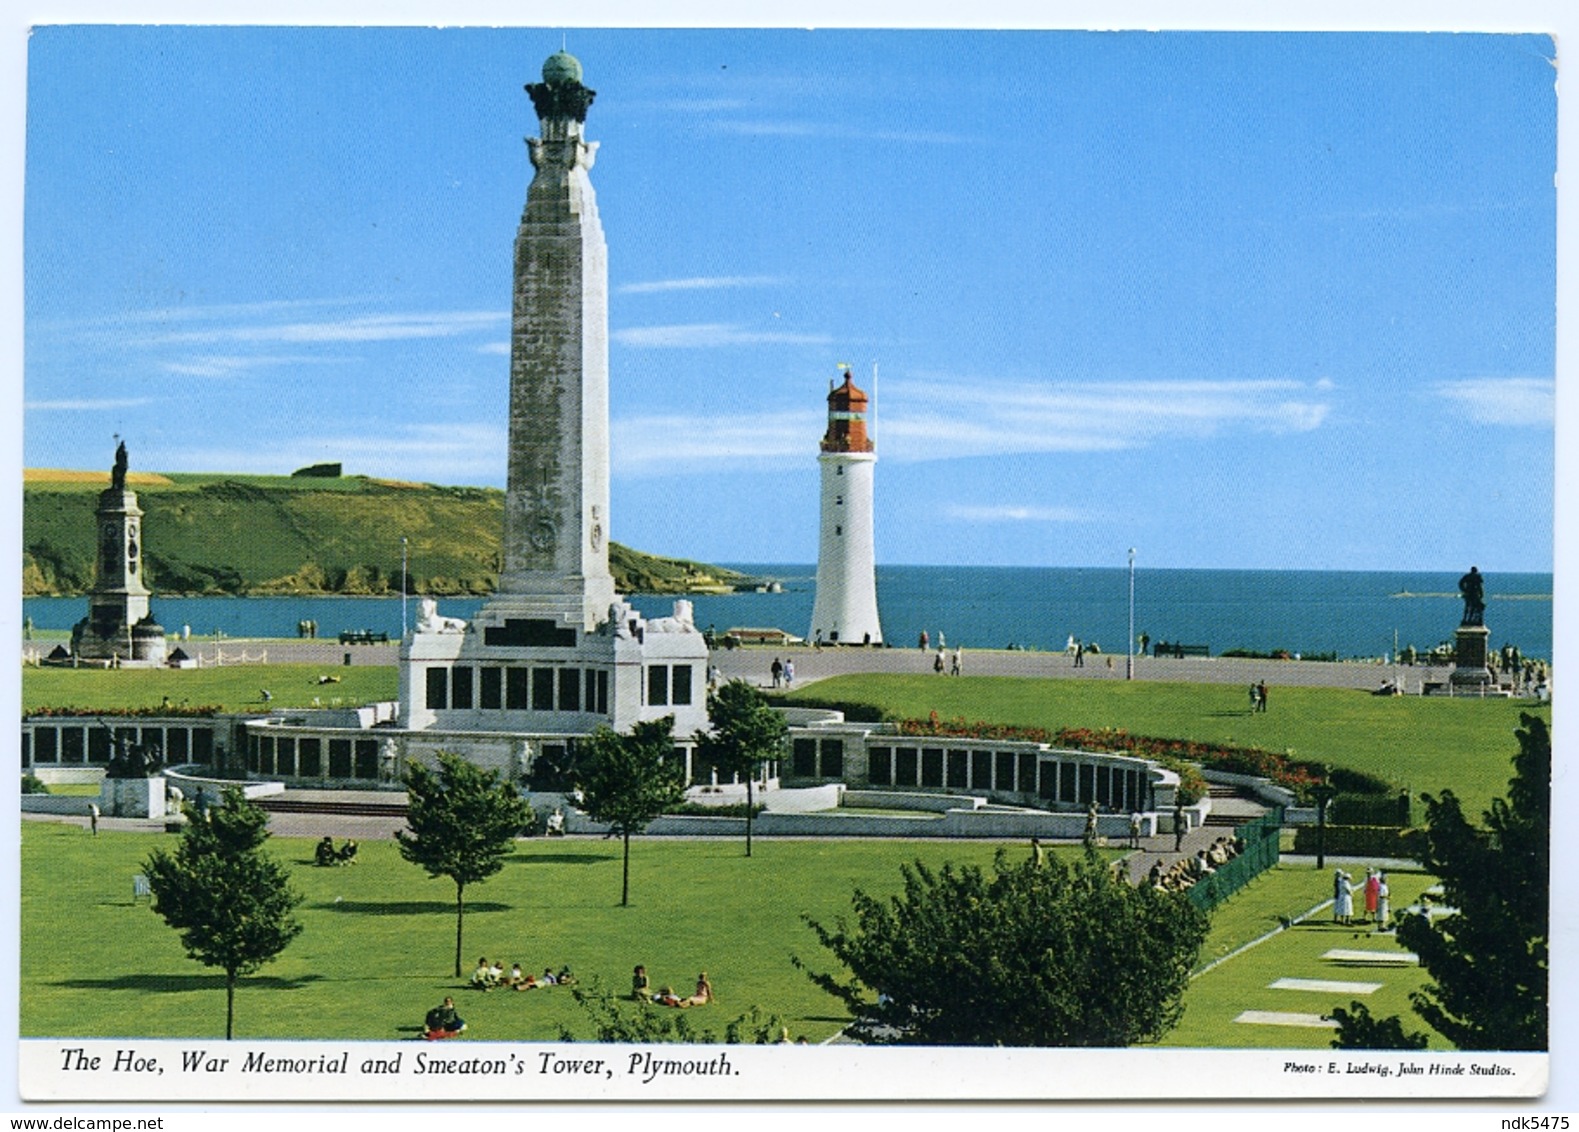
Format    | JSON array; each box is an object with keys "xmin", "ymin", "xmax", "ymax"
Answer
[{"xmin": 401, "ymin": 52, "xmax": 707, "ymax": 754}]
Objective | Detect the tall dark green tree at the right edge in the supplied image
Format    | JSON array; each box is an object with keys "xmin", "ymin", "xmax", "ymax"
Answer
[{"xmin": 1397, "ymin": 714, "xmax": 1552, "ymax": 1050}]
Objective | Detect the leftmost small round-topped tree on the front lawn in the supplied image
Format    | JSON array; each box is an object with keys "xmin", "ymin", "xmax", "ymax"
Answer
[{"xmin": 144, "ymin": 786, "xmax": 302, "ymax": 1040}]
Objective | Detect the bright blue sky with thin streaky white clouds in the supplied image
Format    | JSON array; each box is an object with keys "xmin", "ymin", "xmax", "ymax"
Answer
[{"xmin": 24, "ymin": 27, "xmax": 1557, "ymax": 572}]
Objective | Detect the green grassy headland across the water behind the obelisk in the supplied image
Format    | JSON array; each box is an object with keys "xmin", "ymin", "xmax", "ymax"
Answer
[{"xmin": 22, "ymin": 470, "xmax": 748, "ymax": 597}]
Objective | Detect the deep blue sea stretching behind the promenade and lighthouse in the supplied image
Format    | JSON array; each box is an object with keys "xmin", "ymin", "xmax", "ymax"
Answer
[{"xmin": 22, "ymin": 564, "xmax": 1552, "ymax": 658}]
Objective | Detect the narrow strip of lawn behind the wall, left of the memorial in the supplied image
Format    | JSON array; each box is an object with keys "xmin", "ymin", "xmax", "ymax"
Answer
[{"xmin": 22, "ymin": 665, "xmax": 399, "ymax": 712}]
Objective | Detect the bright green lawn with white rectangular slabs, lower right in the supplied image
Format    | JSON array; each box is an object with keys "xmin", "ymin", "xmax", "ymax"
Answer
[{"xmin": 1162, "ymin": 868, "xmax": 1453, "ymax": 1050}]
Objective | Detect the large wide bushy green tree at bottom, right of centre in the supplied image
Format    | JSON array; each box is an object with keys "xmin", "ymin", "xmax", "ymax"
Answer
[{"xmin": 793, "ymin": 851, "xmax": 1206, "ymax": 1047}]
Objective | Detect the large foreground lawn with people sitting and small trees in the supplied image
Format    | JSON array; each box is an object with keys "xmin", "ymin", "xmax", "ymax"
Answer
[{"xmin": 21, "ymin": 821, "xmax": 1048, "ymax": 1042}]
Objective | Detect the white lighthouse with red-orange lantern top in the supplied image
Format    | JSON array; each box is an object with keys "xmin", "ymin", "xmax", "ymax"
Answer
[{"xmin": 812, "ymin": 369, "xmax": 883, "ymax": 644}]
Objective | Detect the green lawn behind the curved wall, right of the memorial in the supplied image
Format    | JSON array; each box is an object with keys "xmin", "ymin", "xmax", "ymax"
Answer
[{"xmin": 785, "ymin": 674, "xmax": 1551, "ymax": 815}]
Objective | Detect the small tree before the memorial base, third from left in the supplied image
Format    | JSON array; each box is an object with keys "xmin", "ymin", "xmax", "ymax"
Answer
[{"xmin": 576, "ymin": 715, "xmax": 685, "ymax": 906}]
